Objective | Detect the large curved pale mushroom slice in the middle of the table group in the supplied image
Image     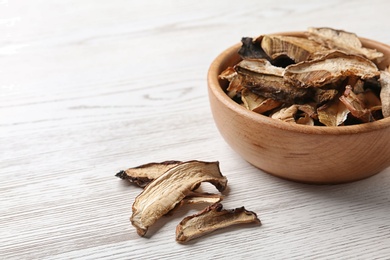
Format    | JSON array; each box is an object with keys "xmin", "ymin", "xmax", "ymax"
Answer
[{"xmin": 130, "ymin": 161, "xmax": 227, "ymax": 236}]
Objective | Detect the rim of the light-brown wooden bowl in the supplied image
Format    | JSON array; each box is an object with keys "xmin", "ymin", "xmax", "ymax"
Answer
[{"xmin": 207, "ymin": 32, "xmax": 390, "ymax": 135}]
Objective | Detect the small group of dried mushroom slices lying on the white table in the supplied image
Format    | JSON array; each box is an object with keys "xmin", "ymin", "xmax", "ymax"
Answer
[{"xmin": 116, "ymin": 161, "xmax": 261, "ymax": 243}]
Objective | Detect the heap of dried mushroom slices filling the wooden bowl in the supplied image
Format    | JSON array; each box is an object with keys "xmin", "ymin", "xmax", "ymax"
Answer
[{"xmin": 219, "ymin": 28, "xmax": 390, "ymax": 126}]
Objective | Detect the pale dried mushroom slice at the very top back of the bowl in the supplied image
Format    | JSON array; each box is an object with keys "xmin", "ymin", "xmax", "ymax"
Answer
[{"xmin": 307, "ymin": 28, "xmax": 384, "ymax": 63}]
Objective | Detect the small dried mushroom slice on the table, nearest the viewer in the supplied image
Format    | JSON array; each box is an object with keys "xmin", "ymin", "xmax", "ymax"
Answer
[{"xmin": 176, "ymin": 203, "xmax": 261, "ymax": 243}]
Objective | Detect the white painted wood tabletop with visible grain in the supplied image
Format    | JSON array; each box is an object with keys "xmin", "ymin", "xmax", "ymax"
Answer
[{"xmin": 0, "ymin": 0, "xmax": 390, "ymax": 259}]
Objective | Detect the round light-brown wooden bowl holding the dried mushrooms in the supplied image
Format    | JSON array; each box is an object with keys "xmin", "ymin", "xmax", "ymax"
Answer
[{"xmin": 208, "ymin": 32, "xmax": 390, "ymax": 184}]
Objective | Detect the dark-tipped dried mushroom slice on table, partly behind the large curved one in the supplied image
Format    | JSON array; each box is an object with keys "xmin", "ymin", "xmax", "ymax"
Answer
[{"xmin": 115, "ymin": 160, "xmax": 182, "ymax": 188}]
